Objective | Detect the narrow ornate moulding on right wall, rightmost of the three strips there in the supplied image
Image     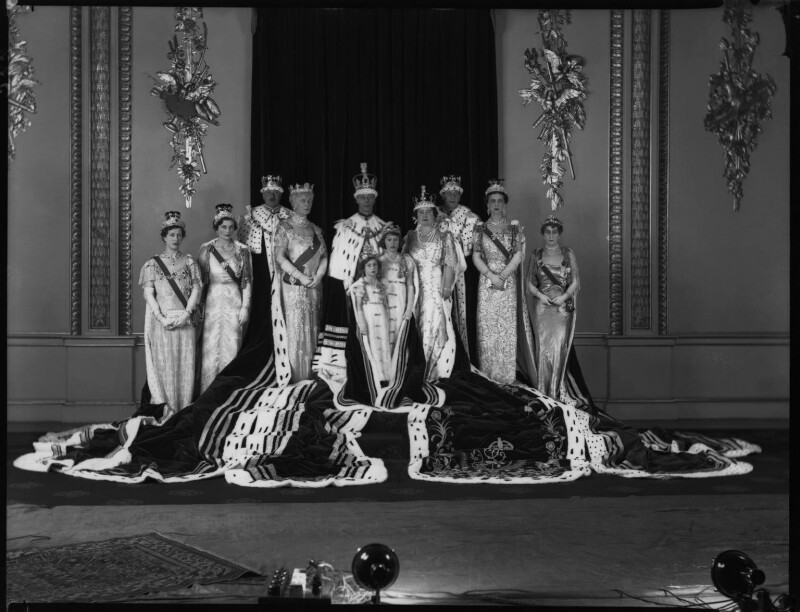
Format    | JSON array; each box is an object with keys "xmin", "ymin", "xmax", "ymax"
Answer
[{"xmin": 658, "ymin": 9, "xmax": 670, "ymax": 336}]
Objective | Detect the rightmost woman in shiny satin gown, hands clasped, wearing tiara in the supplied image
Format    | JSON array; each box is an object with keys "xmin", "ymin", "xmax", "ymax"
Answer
[{"xmin": 527, "ymin": 215, "xmax": 580, "ymax": 401}]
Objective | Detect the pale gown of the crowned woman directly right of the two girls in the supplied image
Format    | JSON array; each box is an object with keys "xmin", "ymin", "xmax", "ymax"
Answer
[{"xmin": 403, "ymin": 229, "xmax": 458, "ymax": 381}]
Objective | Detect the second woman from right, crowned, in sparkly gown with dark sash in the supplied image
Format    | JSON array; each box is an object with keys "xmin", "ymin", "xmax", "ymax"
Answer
[{"xmin": 472, "ymin": 180, "xmax": 525, "ymax": 384}]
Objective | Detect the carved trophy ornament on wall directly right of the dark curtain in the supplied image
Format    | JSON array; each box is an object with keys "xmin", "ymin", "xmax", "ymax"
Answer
[{"xmin": 518, "ymin": 10, "xmax": 586, "ymax": 210}]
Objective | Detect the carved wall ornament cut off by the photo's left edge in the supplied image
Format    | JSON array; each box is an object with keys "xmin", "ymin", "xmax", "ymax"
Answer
[{"xmin": 2, "ymin": 0, "xmax": 41, "ymax": 167}]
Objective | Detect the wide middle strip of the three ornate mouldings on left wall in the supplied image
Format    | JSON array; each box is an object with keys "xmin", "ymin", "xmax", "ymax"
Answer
[{"xmin": 89, "ymin": 6, "xmax": 111, "ymax": 330}]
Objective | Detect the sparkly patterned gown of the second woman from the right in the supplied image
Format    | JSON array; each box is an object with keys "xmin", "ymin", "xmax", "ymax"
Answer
[{"xmin": 472, "ymin": 223, "xmax": 525, "ymax": 384}]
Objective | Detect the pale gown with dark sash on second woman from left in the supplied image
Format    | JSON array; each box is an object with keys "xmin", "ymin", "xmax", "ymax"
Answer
[{"xmin": 198, "ymin": 240, "xmax": 253, "ymax": 393}]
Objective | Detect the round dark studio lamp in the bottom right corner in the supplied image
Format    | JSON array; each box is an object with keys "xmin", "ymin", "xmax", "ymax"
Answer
[{"xmin": 711, "ymin": 550, "xmax": 795, "ymax": 612}]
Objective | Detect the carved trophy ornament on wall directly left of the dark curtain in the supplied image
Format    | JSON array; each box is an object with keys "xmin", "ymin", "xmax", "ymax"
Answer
[{"xmin": 148, "ymin": 7, "xmax": 220, "ymax": 208}]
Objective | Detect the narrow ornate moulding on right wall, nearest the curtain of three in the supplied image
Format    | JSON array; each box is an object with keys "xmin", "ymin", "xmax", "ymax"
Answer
[{"xmin": 608, "ymin": 9, "xmax": 624, "ymax": 336}]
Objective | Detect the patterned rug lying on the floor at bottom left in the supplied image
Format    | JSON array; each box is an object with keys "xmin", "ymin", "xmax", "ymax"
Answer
[{"xmin": 6, "ymin": 533, "xmax": 253, "ymax": 605}]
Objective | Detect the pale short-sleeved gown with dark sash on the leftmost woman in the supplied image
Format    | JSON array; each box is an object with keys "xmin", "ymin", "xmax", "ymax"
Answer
[{"xmin": 139, "ymin": 255, "xmax": 201, "ymax": 420}]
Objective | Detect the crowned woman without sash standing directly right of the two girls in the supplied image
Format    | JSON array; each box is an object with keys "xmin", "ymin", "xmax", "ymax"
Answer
[{"xmin": 403, "ymin": 185, "xmax": 458, "ymax": 381}]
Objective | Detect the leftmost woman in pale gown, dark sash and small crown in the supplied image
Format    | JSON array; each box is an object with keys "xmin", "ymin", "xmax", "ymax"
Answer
[{"xmin": 139, "ymin": 211, "xmax": 201, "ymax": 422}]
